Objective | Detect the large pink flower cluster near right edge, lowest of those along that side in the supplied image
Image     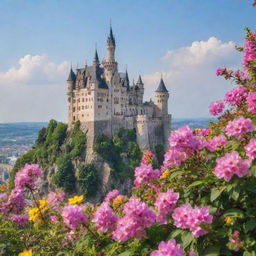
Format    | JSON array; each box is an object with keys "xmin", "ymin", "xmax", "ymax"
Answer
[{"xmin": 213, "ymin": 151, "xmax": 250, "ymax": 180}]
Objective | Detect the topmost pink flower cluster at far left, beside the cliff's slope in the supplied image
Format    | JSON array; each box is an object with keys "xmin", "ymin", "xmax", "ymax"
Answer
[{"xmin": 14, "ymin": 164, "xmax": 43, "ymax": 189}]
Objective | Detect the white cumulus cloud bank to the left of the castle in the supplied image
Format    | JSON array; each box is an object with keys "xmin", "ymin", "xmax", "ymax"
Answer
[{"xmin": 0, "ymin": 54, "xmax": 70, "ymax": 122}]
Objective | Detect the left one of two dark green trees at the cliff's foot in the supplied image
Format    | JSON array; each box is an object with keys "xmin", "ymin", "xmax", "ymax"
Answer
[{"xmin": 54, "ymin": 153, "xmax": 76, "ymax": 192}]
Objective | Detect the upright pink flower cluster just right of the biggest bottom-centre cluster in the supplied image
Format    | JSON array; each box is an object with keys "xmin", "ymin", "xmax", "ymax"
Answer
[{"xmin": 155, "ymin": 189, "xmax": 179, "ymax": 224}]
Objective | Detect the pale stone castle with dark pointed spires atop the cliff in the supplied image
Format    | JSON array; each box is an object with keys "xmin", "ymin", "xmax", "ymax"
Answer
[{"xmin": 67, "ymin": 27, "xmax": 171, "ymax": 149}]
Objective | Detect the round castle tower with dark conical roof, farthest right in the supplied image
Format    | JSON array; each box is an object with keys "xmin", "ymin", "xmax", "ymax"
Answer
[{"xmin": 155, "ymin": 77, "xmax": 169, "ymax": 116}]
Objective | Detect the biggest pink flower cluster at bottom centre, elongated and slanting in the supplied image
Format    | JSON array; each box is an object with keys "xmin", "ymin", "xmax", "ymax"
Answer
[{"xmin": 112, "ymin": 196, "xmax": 156, "ymax": 241}]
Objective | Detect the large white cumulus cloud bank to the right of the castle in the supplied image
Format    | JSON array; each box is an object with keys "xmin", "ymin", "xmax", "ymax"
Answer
[{"xmin": 143, "ymin": 37, "xmax": 241, "ymax": 117}]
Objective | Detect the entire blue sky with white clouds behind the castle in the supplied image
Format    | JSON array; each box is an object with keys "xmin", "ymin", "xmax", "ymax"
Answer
[{"xmin": 0, "ymin": 0, "xmax": 256, "ymax": 122}]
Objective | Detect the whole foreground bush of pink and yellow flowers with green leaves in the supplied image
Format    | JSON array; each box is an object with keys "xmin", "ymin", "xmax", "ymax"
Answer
[{"xmin": 0, "ymin": 30, "xmax": 256, "ymax": 256}]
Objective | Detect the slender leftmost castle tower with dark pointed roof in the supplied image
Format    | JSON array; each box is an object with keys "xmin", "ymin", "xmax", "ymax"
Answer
[{"xmin": 67, "ymin": 67, "xmax": 76, "ymax": 124}]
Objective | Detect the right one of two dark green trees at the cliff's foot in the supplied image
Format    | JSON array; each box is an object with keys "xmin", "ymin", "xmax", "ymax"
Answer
[{"xmin": 78, "ymin": 164, "xmax": 99, "ymax": 196}]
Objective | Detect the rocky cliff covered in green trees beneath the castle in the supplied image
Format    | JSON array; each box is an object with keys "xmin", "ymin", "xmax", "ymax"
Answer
[{"xmin": 10, "ymin": 120, "xmax": 142, "ymax": 202}]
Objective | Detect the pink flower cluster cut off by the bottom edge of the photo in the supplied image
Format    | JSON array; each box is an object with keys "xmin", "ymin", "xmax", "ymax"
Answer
[{"xmin": 150, "ymin": 239, "xmax": 185, "ymax": 256}]
